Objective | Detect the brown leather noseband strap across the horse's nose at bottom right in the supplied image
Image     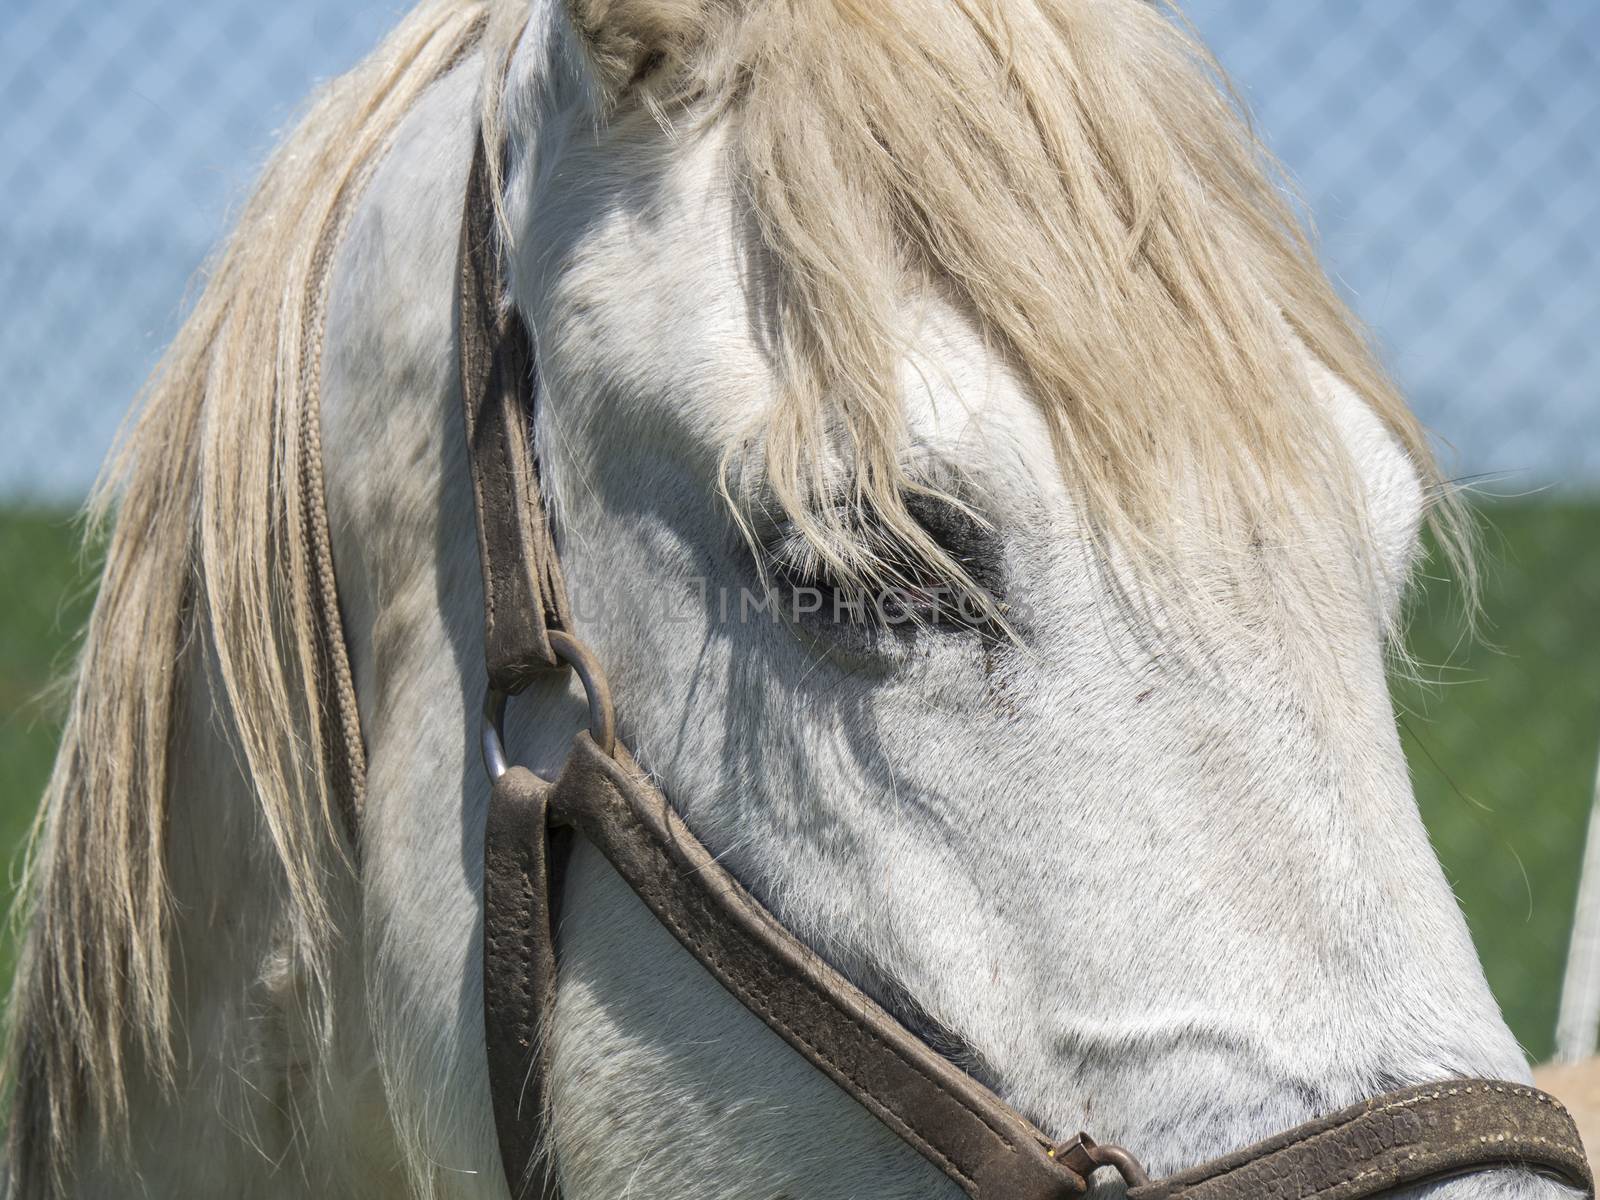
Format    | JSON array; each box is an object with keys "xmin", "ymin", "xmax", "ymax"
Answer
[{"xmin": 1128, "ymin": 1080, "xmax": 1594, "ymax": 1200}]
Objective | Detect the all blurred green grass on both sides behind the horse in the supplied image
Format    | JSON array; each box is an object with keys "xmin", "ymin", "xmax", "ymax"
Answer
[{"xmin": 0, "ymin": 501, "xmax": 1600, "ymax": 1058}]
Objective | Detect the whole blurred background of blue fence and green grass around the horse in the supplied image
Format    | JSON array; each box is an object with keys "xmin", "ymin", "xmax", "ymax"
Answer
[{"xmin": 0, "ymin": 0, "xmax": 1600, "ymax": 1058}]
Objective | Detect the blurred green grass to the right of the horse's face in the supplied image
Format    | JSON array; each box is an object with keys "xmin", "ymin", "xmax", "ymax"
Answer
[{"xmin": 1394, "ymin": 501, "xmax": 1600, "ymax": 1059}]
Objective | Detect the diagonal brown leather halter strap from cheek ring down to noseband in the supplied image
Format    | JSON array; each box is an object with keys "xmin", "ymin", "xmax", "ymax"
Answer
[{"xmin": 547, "ymin": 733, "xmax": 1085, "ymax": 1200}]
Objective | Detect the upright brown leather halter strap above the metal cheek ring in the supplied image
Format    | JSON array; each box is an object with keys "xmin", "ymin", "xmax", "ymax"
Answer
[{"xmin": 456, "ymin": 136, "xmax": 568, "ymax": 693}]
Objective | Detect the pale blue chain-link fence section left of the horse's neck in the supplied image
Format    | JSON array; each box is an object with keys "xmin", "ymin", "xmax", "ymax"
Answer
[{"xmin": 0, "ymin": 0, "xmax": 403, "ymax": 501}]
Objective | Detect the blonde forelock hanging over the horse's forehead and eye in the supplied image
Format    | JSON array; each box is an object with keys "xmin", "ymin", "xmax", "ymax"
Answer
[{"xmin": 579, "ymin": 0, "xmax": 1459, "ymax": 601}]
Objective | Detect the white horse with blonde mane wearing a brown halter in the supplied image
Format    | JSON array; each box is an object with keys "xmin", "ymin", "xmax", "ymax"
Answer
[{"xmin": 10, "ymin": 0, "xmax": 1560, "ymax": 1200}]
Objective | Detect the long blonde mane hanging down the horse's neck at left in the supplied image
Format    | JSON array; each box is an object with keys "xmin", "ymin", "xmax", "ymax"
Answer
[{"xmin": 6, "ymin": 0, "xmax": 515, "ymax": 1195}]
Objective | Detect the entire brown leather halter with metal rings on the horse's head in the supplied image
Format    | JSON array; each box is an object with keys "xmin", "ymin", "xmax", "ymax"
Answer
[{"xmin": 441, "ymin": 124, "xmax": 1594, "ymax": 1200}]
